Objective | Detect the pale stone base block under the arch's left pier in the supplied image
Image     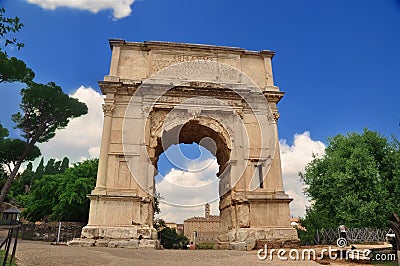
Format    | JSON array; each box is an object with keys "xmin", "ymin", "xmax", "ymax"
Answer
[{"xmin": 69, "ymin": 193, "xmax": 157, "ymax": 248}]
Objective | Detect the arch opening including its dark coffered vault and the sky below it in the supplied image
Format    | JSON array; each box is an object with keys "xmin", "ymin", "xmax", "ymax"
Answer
[{"xmin": 150, "ymin": 118, "xmax": 231, "ymax": 223}]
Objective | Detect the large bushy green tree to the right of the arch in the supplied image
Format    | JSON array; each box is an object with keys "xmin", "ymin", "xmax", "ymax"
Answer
[{"xmin": 300, "ymin": 129, "xmax": 400, "ymax": 243}]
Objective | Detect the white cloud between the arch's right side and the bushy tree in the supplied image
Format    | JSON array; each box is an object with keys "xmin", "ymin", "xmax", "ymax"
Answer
[{"xmin": 280, "ymin": 131, "xmax": 325, "ymax": 219}]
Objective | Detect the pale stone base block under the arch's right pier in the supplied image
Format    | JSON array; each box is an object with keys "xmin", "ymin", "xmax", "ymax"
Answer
[{"xmin": 217, "ymin": 192, "xmax": 298, "ymax": 250}]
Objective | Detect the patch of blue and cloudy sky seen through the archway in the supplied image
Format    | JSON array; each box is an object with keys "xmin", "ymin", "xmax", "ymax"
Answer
[{"xmin": 155, "ymin": 143, "xmax": 219, "ymax": 218}]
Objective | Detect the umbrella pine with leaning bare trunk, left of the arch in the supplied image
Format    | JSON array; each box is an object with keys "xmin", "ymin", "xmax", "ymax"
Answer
[{"xmin": 0, "ymin": 82, "xmax": 87, "ymax": 206}]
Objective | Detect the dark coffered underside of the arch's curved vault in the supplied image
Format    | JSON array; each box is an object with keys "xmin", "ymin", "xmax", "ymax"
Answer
[{"xmin": 155, "ymin": 120, "xmax": 231, "ymax": 175}]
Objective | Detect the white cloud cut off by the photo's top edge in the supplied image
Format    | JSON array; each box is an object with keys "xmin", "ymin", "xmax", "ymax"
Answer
[{"xmin": 27, "ymin": 0, "xmax": 135, "ymax": 19}]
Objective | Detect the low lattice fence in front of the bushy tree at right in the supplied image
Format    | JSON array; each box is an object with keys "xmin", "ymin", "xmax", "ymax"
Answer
[{"xmin": 315, "ymin": 228, "xmax": 393, "ymax": 245}]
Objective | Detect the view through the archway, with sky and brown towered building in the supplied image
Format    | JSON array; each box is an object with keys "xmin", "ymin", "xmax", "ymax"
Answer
[{"xmin": 154, "ymin": 140, "xmax": 220, "ymax": 244}]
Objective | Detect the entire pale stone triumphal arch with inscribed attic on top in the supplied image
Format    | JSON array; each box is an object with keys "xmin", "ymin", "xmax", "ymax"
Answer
[{"xmin": 77, "ymin": 39, "xmax": 297, "ymax": 249}]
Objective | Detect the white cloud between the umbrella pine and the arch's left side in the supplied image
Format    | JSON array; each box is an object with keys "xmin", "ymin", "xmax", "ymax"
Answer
[{"xmin": 38, "ymin": 86, "xmax": 103, "ymax": 162}]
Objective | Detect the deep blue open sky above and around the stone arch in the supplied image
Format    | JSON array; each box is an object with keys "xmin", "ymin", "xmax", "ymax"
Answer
[{"xmin": 0, "ymin": 0, "xmax": 400, "ymax": 221}]
